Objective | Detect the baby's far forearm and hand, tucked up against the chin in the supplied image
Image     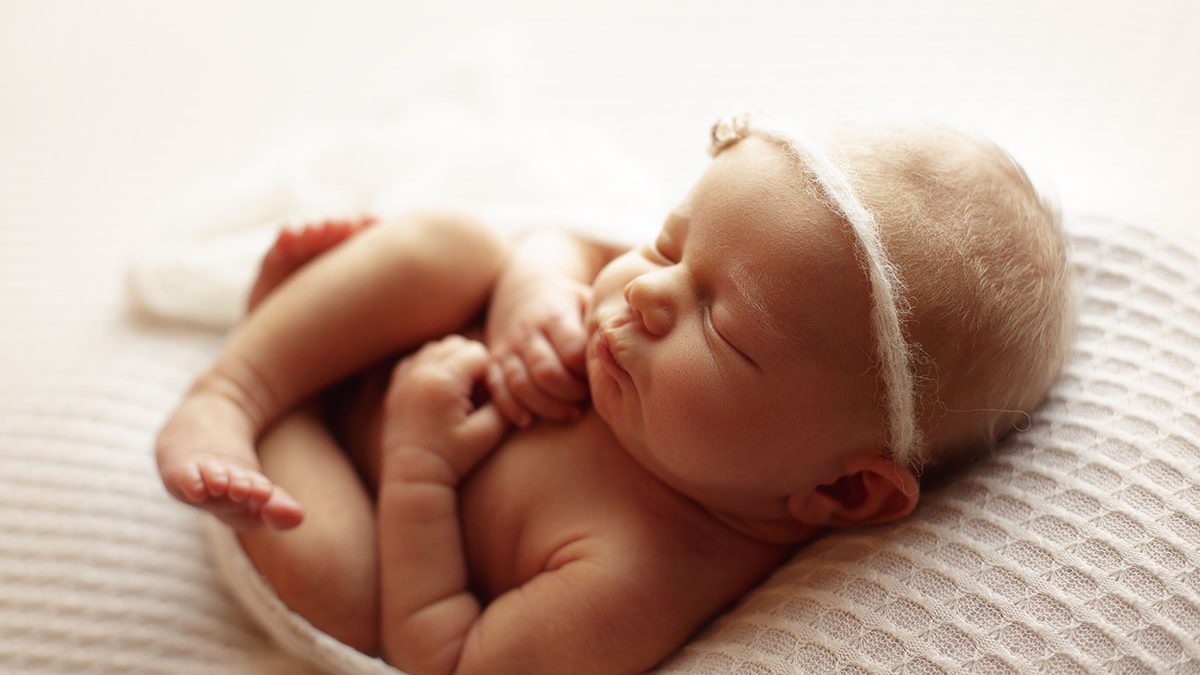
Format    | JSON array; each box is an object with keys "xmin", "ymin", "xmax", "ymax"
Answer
[{"xmin": 487, "ymin": 231, "xmax": 622, "ymax": 426}]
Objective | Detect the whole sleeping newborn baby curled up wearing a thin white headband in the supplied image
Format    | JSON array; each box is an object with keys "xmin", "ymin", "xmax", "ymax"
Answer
[{"xmin": 157, "ymin": 115, "xmax": 1070, "ymax": 674}]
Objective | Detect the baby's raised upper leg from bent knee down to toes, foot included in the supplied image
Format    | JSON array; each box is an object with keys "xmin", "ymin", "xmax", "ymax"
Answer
[{"xmin": 157, "ymin": 215, "xmax": 506, "ymax": 527}]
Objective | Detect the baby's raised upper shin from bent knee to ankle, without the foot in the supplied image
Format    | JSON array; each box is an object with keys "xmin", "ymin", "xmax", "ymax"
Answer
[{"xmin": 202, "ymin": 215, "xmax": 503, "ymax": 417}]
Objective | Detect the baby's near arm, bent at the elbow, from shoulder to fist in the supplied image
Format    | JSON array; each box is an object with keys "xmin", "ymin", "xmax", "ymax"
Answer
[{"xmin": 377, "ymin": 338, "xmax": 705, "ymax": 675}]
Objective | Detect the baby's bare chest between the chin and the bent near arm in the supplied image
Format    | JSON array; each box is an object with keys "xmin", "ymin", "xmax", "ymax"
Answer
[{"xmin": 460, "ymin": 412, "xmax": 633, "ymax": 601}]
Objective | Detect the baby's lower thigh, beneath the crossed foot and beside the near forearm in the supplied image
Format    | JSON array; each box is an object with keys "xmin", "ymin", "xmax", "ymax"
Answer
[{"xmin": 238, "ymin": 405, "xmax": 379, "ymax": 653}]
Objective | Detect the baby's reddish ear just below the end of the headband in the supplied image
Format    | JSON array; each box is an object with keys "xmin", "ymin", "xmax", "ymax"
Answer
[{"xmin": 787, "ymin": 452, "xmax": 920, "ymax": 527}]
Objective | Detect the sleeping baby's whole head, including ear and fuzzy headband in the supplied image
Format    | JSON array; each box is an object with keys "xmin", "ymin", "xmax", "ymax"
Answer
[{"xmin": 588, "ymin": 118, "xmax": 1070, "ymax": 537}]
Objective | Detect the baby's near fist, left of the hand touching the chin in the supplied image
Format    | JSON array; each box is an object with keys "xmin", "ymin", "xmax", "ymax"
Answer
[{"xmin": 383, "ymin": 335, "xmax": 508, "ymax": 485}]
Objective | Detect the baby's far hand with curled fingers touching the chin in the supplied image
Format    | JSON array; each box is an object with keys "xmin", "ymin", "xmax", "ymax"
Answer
[{"xmin": 487, "ymin": 270, "xmax": 590, "ymax": 428}]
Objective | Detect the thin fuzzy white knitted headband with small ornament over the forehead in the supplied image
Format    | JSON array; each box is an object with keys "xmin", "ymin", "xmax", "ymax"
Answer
[{"xmin": 709, "ymin": 113, "xmax": 923, "ymax": 466}]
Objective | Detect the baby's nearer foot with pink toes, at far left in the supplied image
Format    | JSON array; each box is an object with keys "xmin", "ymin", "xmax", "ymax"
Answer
[{"xmin": 157, "ymin": 393, "xmax": 304, "ymax": 530}]
